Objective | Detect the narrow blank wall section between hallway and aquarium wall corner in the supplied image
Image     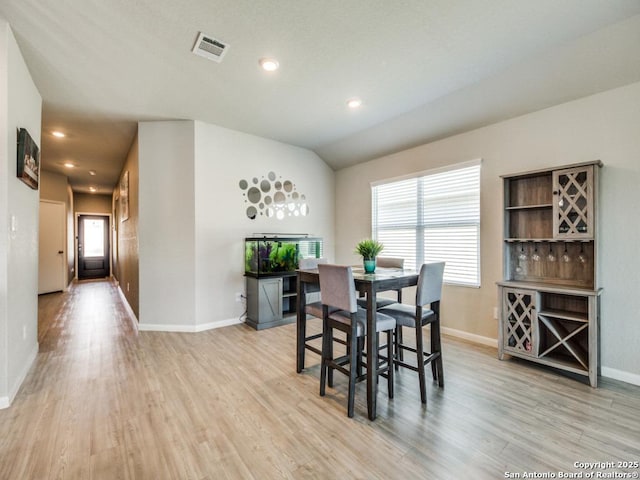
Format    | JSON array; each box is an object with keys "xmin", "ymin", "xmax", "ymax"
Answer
[{"xmin": 138, "ymin": 121, "xmax": 196, "ymax": 330}]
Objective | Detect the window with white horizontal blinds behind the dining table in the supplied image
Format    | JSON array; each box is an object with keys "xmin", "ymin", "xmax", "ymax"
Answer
[{"xmin": 372, "ymin": 161, "xmax": 480, "ymax": 287}]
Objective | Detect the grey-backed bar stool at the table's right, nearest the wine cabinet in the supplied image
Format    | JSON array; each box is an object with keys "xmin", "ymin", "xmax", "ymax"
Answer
[{"xmin": 378, "ymin": 262, "xmax": 444, "ymax": 404}]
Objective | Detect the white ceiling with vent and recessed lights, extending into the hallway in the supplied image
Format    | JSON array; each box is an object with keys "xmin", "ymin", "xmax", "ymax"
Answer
[{"xmin": 0, "ymin": 0, "xmax": 640, "ymax": 193}]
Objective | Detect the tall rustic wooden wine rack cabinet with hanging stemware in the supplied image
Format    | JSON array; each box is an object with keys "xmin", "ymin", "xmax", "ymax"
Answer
[{"xmin": 498, "ymin": 161, "xmax": 602, "ymax": 387}]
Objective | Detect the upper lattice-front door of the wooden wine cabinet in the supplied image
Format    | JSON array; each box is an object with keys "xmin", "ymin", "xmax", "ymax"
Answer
[{"xmin": 553, "ymin": 165, "xmax": 594, "ymax": 239}]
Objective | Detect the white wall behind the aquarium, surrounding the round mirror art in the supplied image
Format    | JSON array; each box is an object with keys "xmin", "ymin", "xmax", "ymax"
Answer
[{"xmin": 195, "ymin": 122, "xmax": 335, "ymax": 328}]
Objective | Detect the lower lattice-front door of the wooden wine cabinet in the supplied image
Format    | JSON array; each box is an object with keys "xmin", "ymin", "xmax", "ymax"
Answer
[{"xmin": 502, "ymin": 288, "xmax": 538, "ymax": 357}]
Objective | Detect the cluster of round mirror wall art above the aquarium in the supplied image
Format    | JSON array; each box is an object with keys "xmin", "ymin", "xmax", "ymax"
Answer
[{"xmin": 238, "ymin": 172, "xmax": 309, "ymax": 220}]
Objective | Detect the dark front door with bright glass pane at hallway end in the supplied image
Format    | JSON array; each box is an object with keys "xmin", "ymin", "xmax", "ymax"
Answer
[{"xmin": 78, "ymin": 215, "xmax": 110, "ymax": 280}]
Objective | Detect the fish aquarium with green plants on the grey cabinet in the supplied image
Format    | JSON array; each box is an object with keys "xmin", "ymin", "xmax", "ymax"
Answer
[{"xmin": 244, "ymin": 235, "xmax": 322, "ymax": 277}]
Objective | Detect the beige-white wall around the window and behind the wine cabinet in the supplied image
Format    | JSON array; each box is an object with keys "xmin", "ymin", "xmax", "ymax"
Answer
[{"xmin": 336, "ymin": 83, "xmax": 640, "ymax": 384}]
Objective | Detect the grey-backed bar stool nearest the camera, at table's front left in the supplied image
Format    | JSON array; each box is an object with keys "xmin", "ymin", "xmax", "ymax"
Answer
[{"xmin": 318, "ymin": 264, "xmax": 396, "ymax": 417}]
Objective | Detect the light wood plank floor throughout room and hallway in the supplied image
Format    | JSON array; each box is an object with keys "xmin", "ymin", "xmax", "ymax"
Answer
[{"xmin": 0, "ymin": 281, "xmax": 640, "ymax": 480}]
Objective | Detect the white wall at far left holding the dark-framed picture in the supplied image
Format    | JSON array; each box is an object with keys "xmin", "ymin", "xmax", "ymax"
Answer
[{"xmin": 0, "ymin": 19, "xmax": 42, "ymax": 408}]
